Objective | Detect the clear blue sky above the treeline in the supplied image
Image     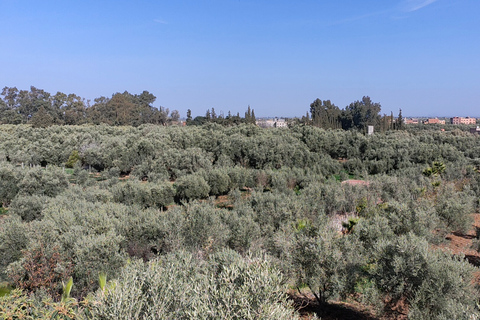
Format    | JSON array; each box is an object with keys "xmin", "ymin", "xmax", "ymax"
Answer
[{"xmin": 0, "ymin": 0, "xmax": 480, "ymax": 116}]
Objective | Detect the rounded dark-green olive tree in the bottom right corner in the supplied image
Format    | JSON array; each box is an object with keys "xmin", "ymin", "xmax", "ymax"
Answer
[{"xmin": 371, "ymin": 233, "xmax": 480, "ymax": 319}]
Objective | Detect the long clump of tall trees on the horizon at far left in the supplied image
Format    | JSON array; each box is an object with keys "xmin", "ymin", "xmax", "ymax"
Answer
[{"xmin": 0, "ymin": 86, "xmax": 180, "ymax": 127}]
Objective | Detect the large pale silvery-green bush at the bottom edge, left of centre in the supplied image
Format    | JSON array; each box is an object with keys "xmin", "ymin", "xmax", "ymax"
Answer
[{"xmin": 84, "ymin": 251, "xmax": 298, "ymax": 320}]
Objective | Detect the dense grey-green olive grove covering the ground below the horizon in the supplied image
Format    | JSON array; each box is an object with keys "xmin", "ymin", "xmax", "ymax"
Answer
[{"xmin": 0, "ymin": 123, "xmax": 480, "ymax": 319}]
